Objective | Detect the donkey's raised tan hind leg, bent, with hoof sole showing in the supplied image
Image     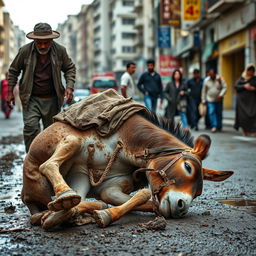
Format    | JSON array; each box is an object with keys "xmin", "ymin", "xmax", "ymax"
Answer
[{"xmin": 39, "ymin": 135, "xmax": 81, "ymax": 211}]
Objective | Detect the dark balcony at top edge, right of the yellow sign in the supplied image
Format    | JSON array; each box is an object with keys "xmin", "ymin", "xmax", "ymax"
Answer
[{"xmin": 207, "ymin": 0, "xmax": 244, "ymax": 13}]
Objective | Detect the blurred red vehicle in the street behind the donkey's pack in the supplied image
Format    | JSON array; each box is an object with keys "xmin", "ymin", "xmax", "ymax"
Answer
[{"xmin": 91, "ymin": 72, "xmax": 118, "ymax": 94}]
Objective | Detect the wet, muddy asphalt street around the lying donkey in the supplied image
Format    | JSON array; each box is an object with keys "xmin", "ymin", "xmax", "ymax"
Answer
[{"xmin": 0, "ymin": 109, "xmax": 256, "ymax": 256}]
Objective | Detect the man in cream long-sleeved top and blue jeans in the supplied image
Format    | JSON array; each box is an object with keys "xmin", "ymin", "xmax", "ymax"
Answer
[{"xmin": 202, "ymin": 69, "xmax": 227, "ymax": 132}]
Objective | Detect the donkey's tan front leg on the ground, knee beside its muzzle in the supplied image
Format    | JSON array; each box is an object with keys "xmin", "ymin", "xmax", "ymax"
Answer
[{"xmin": 94, "ymin": 186, "xmax": 151, "ymax": 227}]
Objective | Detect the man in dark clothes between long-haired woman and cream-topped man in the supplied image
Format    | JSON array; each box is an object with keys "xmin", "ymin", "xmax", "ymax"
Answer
[{"xmin": 187, "ymin": 69, "xmax": 203, "ymax": 131}]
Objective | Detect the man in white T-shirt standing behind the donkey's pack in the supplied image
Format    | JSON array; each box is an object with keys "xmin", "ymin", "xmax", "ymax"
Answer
[{"xmin": 121, "ymin": 62, "xmax": 136, "ymax": 98}]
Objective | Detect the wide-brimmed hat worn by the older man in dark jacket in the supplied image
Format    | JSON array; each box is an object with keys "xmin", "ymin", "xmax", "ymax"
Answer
[{"xmin": 26, "ymin": 23, "xmax": 60, "ymax": 39}]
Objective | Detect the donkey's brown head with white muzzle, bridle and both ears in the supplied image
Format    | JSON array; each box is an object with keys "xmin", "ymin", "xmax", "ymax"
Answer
[{"xmin": 147, "ymin": 135, "xmax": 233, "ymax": 218}]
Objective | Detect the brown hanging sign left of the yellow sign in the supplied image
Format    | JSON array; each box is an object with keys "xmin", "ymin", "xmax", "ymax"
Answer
[{"xmin": 160, "ymin": 0, "xmax": 181, "ymax": 27}]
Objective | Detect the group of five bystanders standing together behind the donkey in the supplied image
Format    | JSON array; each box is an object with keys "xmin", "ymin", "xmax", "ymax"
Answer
[{"xmin": 120, "ymin": 60, "xmax": 227, "ymax": 132}]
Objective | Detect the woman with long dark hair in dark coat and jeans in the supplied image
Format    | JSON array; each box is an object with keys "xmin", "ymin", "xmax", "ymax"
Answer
[{"xmin": 164, "ymin": 69, "xmax": 188, "ymax": 129}]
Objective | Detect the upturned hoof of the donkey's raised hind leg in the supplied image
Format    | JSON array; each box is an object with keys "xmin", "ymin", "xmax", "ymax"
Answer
[{"xmin": 48, "ymin": 189, "xmax": 81, "ymax": 212}]
